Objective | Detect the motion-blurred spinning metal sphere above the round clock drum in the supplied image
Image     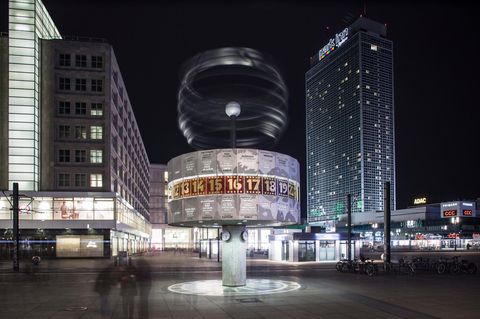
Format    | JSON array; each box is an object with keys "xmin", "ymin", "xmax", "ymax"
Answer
[{"xmin": 178, "ymin": 47, "xmax": 288, "ymax": 149}]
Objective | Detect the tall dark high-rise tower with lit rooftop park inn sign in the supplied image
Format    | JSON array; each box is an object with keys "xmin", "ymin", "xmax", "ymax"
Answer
[{"xmin": 305, "ymin": 17, "xmax": 395, "ymax": 223}]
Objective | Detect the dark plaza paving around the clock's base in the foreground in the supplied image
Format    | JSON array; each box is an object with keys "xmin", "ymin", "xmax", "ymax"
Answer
[{"xmin": 0, "ymin": 253, "xmax": 480, "ymax": 319}]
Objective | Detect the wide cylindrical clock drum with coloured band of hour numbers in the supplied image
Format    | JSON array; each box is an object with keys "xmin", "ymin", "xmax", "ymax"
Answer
[{"xmin": 168, "ymin": 148, "xmax": 300, "ymax": 228}]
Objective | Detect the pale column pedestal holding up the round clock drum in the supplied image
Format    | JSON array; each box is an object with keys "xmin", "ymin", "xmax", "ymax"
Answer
[{"xmin": 222, "ymin": 225, "xmax": 247, "ymax": 287}]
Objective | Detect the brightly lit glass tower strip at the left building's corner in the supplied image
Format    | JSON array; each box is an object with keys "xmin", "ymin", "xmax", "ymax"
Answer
[{"xmin": 8, "ymin": 0, "xmax": 61, "ymax": 191}]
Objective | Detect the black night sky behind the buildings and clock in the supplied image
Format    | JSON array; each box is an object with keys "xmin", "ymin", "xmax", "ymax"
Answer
[{"xmin": 0, "ymin": 0, "xmax": 480, "ymax": 210}]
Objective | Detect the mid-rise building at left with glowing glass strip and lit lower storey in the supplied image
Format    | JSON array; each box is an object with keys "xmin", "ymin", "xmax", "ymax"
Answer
[{"xmin": 0, "ymin": 0, "xmax": 151, "ymax": 257}]
